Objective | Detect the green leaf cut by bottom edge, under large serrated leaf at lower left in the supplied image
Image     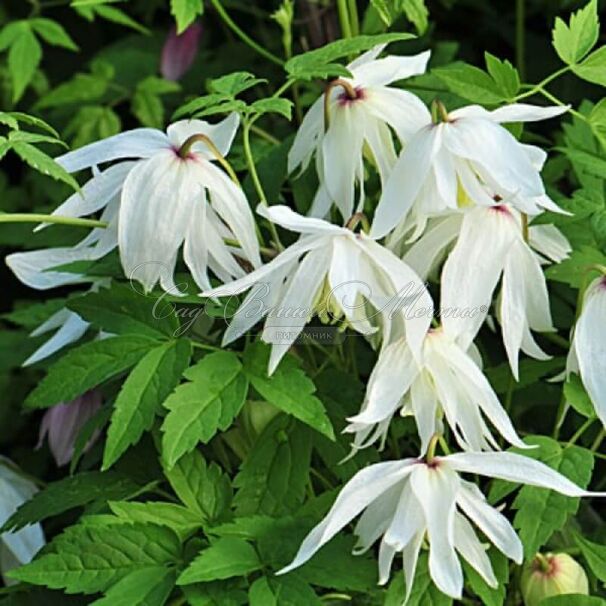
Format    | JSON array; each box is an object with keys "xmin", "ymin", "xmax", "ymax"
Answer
[{"xmin": 91, "ymin": 566, "xmax": 175, "ymax": 606}]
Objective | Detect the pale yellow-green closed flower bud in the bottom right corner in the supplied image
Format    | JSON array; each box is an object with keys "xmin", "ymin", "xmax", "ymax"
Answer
[{"xmin": 522, "ymin": 553, "xmax": 589, "ymax": 606}]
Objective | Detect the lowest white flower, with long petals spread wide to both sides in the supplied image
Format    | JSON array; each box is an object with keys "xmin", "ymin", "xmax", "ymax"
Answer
[{"xmin": 278, "ymin": 452, "xmax": 606, "ymax": 600}]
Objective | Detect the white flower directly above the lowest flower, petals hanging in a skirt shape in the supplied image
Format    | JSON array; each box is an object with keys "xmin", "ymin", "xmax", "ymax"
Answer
[{"xmin": 345, "ymin": 328, "xmax": 525, "ymax": 454}]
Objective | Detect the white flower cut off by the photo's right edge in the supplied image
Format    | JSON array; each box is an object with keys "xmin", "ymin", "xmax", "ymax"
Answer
[{"xmin": 571, "ymin": 276, "xmax": 606, "ymax": 426}]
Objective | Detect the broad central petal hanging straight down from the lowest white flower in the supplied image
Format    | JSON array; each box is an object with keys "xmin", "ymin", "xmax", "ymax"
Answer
[{"xmin": 410, "ymin": 465, "xmax": 463, "ymax": 599}]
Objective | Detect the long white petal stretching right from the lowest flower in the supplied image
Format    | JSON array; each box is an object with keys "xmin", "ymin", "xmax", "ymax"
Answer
[{"xmin": 447, "ymin": 452, "xmax": 606, "ymax": 497}]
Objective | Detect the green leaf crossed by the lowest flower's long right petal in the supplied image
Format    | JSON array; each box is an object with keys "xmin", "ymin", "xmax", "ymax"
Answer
[{"xmin": 512, "ymin": 436, "xmax": 594, "ymax": 558}]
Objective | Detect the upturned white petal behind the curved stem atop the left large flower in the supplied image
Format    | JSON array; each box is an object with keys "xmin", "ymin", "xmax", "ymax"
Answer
[{"xmin": 166, "ymin": 112, "xmax": 240, "ymax": 160}]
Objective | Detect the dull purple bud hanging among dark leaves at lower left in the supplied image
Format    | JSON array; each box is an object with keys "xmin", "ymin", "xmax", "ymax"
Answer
[{"xmin": 38, "ymin": 389, "xmax": 102, "ymax": 467}]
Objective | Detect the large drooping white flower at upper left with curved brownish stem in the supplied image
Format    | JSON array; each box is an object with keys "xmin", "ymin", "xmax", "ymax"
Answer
[{"xmin": 53, "ymin": 114, "xmax": 261, "ymax": 293}]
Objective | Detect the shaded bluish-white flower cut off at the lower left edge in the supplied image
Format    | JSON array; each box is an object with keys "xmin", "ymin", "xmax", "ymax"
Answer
[{"xmin": 0, "ymin": 457, "xmax": 45, "ymax": 583}]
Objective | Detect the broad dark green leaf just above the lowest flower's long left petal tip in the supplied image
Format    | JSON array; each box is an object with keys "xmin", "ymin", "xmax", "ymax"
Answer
[{"xmin": 234, "ymin": 415, "xmax": 311, "ymax": 516}]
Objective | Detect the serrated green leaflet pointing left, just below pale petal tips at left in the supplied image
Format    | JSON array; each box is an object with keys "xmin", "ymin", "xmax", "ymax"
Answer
[{"xmin": 25, "ymin": 335, "xmax": 158, "ymax": 408}]
